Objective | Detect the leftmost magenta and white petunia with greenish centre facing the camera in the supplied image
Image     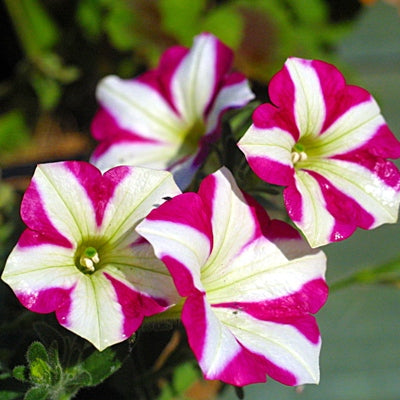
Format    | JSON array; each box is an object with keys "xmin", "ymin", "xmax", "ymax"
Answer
[{"xmin": 2, "ymin": 161, "xmax": 180, "ymax": 350}]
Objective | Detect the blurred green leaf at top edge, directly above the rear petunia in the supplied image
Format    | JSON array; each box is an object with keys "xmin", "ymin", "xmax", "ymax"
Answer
[{"xmin": 158, "ymin": 0, "xmax": 206, "ymax": 46}]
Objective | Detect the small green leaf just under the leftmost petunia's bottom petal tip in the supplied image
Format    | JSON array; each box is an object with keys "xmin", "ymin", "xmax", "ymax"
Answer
[{"xmin": 82, "ymin": 348, "xmax": 122, "ymax": 386}]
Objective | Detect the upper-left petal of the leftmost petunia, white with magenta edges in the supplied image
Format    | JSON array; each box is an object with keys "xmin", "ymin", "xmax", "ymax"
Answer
[{"xmin": 21, "ymin": 161, "xmax": 102, "ymax": 243}]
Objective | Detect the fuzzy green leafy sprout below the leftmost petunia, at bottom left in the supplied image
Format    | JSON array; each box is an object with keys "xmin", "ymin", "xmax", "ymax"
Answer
[{"xmin": 13, "ymin": 341, "xmax": 121, "ymax": 400}]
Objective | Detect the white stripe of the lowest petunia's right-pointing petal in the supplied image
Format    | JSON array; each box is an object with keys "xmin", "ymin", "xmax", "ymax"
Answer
[{"xmin": 203, "ymin": 238, "xmax": 326, "ymax": 304}]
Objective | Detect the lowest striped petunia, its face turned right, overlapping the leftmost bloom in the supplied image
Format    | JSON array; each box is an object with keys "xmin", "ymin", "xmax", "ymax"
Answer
[{"xmin": 137, "ymin": 168, "xmax": 327, "ymax": 386}]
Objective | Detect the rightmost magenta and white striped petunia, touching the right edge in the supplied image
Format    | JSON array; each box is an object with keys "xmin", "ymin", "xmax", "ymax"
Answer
[{"xmin": 238, "ymin": 58, "xmax": 400, "ymax": 247}]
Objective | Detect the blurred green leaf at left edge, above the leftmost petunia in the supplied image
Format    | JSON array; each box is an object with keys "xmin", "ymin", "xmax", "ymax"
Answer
[{"xmin": 0, "ymin": 110, "xmax": 29, "ymax": 154}]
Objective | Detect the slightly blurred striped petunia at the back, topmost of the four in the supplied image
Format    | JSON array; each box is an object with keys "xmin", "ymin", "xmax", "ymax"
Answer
[{"xmin": 91, "ymin": 33, "xmax": 254, "ymax": 188}]
